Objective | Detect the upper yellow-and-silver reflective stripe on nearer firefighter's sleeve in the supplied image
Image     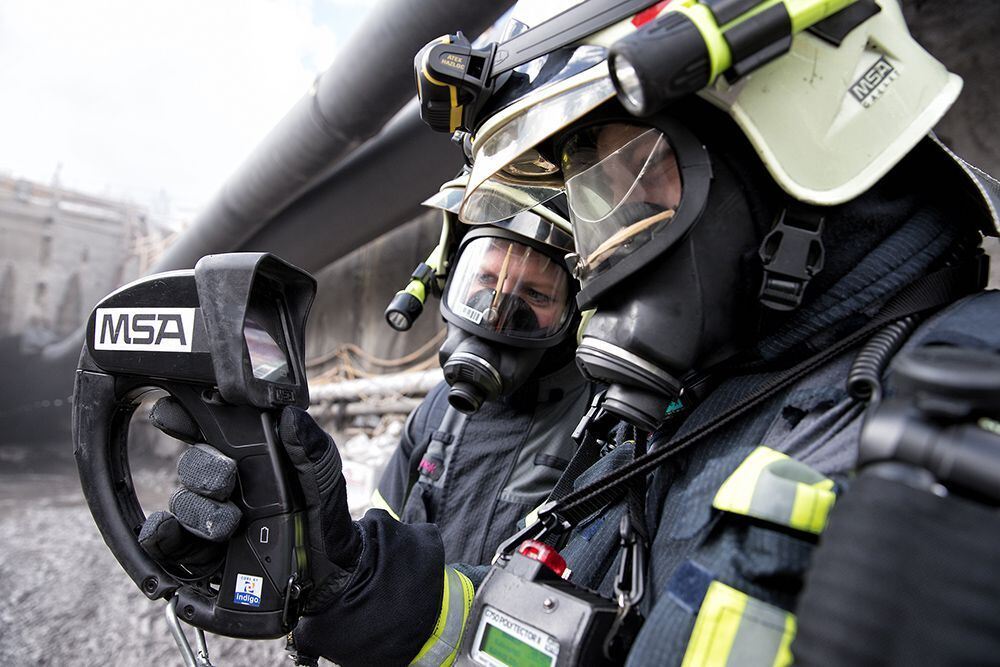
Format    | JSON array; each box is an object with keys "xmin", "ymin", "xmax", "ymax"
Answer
[{"xmin": 712, "ymin": 447, "xmax": 837, "ymax": 535}]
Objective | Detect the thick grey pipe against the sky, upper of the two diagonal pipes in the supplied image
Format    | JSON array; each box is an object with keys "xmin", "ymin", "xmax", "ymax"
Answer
[{"xmin": 152, "ymin": 0, "xmax": 511, "ymax": 272}]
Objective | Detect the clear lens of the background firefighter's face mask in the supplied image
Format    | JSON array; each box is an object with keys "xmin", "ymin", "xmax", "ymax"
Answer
[{"xmin": 444, "ymin": 237, "xmax": 571, "ymax": 340}]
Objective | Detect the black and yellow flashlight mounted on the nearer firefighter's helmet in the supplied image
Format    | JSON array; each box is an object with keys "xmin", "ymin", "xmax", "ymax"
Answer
[{"xmin": 608, "ymin": 0, "xmax": 878, "ymax": 116}]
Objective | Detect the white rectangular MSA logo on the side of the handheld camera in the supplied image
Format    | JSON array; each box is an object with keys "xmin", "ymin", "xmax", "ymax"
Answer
[{"xmin": 94, "ymin": 308, "xmax": 195, "ymax": 352}]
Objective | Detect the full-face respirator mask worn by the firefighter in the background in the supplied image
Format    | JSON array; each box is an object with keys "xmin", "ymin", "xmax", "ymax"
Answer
[{"xmin": 439, "ymin": 224, "xmax": 576, "ymax": 413}]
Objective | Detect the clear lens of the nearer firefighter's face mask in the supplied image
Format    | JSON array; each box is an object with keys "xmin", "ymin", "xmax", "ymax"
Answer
[{"xmin": 561, "ymin": 123, "xmax": 682, "ymax": 279}]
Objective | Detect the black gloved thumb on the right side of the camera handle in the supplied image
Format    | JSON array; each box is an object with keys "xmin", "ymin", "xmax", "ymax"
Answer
[{"xmin": 278, "ymin": 406, "xmax": 361, "ymax": 569}]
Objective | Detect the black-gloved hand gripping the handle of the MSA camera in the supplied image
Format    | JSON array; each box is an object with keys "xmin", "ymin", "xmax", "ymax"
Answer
[{"xmin": 139, "ymin": 397, "xmax": 363, "ymax": 613}]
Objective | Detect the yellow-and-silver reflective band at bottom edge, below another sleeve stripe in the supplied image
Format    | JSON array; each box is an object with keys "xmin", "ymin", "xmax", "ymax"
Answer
[{"xmin": 681, "ymin": 581, "xmax": 795, "ymax": 667}]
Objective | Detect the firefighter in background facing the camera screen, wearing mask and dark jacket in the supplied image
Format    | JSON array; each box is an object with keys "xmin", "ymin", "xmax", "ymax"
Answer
[{"xmin": 372, "ymin": 185, "xmax": 593, "ymax": 563}]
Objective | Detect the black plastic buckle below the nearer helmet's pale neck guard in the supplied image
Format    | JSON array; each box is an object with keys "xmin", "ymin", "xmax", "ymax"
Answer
[{"xmin": 758, "ymin": 208, "xmax": 824, "ymax": 311}]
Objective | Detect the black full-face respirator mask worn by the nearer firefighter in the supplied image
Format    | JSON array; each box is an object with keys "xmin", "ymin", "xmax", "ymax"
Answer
[{"xmin": 557, "ymin": 117, "xmax": 760, "ymax": 431}]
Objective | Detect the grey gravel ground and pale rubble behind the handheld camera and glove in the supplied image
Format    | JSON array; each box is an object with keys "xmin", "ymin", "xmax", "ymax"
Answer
[{"xmin": 0, "ymin": 414, "xmax": 399, "ymax": 667}]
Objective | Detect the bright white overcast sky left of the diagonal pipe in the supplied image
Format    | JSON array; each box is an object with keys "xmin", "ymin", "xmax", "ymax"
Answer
[{"xmin": 0, "ymin": 0, "xmax": 374, "ymax": 220}]
